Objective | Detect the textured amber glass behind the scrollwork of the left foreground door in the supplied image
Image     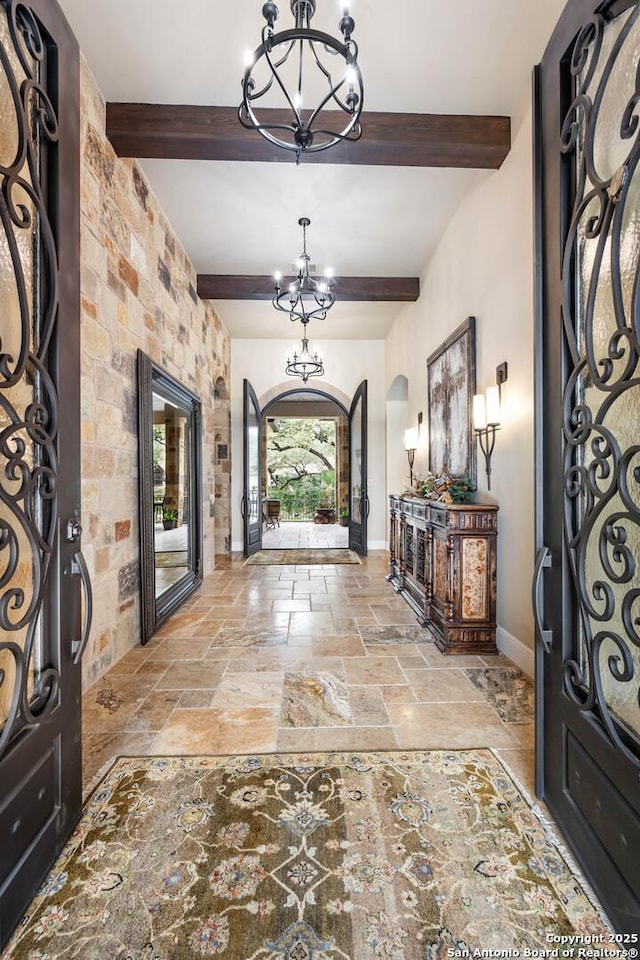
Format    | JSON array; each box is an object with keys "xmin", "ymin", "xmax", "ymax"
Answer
[{"xmin": 0, "ymin": 5, "xmax": 46, "ymax": 728}]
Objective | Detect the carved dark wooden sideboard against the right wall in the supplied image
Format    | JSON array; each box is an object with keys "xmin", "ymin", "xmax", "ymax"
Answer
[{"xmin": 387, "ymin": 497, "xmax": 498, "ymax": 653}]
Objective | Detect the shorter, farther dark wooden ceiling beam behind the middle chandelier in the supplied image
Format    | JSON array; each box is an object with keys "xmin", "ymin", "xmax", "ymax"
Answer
[{"xmin": 197, "ymin": 273, "xmax": 420, "ymax": 303}]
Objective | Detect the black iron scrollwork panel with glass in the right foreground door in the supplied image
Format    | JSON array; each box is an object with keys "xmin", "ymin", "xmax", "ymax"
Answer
[{"xmin": 561, "ymin": 3, "xmax": 640, "ymax": 762}]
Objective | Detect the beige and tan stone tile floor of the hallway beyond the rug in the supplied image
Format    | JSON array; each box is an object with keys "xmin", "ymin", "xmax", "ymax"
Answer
[{"xmin": 84, "ymin": 551, "xmax": 534, "ymax": 792}]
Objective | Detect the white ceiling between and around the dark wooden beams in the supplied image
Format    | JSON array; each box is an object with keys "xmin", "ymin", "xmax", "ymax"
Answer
[{"xmin": 59, "ymin": 0, "xmax": 564, "ymax": 339}]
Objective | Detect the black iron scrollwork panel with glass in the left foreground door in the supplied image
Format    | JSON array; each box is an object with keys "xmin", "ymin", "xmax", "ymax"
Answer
[{"xmin": 0, "ymin": 0, "xmax": 59, "ymax": 755}]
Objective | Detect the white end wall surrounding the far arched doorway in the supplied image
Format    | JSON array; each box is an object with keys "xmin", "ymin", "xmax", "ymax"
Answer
[{"xmin": 231, "ymin": 338, "xmax": 387, "ymax": 550}]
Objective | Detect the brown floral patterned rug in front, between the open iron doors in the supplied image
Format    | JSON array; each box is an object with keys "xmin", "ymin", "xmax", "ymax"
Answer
[{"xmin": 5, "ymin": 750, "xmax": 607, "ymax": 960}]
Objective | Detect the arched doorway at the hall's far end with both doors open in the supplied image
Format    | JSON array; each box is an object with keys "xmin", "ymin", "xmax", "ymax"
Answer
[{"xmin": 243, "ymin": 381, "xmax": 368, "ymax": 555}]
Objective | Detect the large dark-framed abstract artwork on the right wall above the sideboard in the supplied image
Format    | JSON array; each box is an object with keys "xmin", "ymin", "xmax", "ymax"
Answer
[{"xmin": 427, "ymin": 317, "xmax": 476, "ymax": 485}]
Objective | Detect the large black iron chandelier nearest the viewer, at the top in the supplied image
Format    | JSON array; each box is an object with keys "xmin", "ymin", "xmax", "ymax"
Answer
[{"xmin": 238, "ymin": 0, "xmax": 364, "ymax": 163}]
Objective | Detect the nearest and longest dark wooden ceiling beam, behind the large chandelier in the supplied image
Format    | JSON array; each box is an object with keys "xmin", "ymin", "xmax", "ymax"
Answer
[{"xmin": 107, "ymin": 103, "xmax": 511, "ymax": 170}]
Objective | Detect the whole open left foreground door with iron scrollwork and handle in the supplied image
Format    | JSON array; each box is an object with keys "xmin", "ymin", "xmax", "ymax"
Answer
[{"xmin": 0, "ymin": 0, "xmax": 84, "ymax": 948}]
